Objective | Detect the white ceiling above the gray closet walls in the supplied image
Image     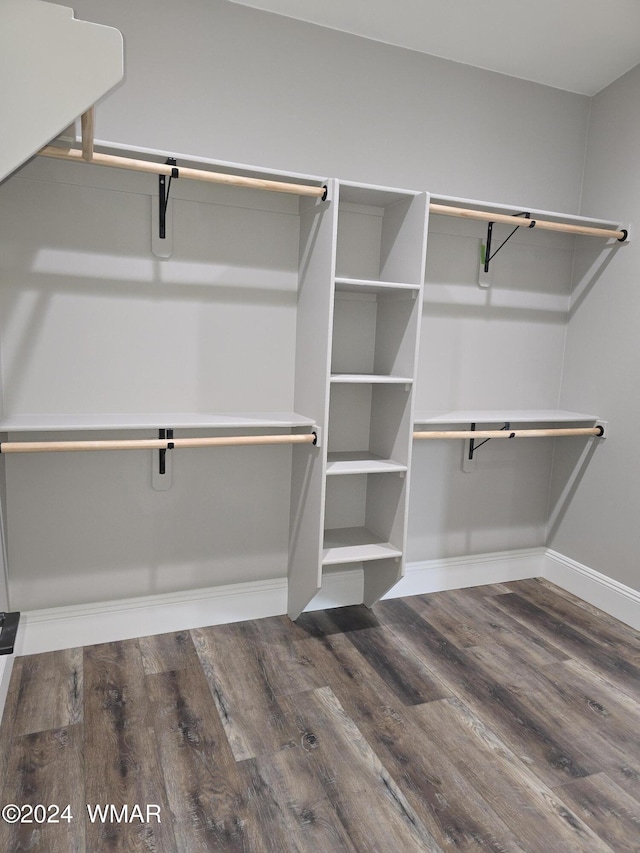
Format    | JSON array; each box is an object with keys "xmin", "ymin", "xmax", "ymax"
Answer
[{"xmin": 231, "ymin": 0, "xmax": 640, "ymax": 95}]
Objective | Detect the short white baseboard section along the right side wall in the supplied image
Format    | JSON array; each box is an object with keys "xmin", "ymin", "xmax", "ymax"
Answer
[{"xmin": 541, "ymin": 548, "xmax": 640, "ymax": 629}]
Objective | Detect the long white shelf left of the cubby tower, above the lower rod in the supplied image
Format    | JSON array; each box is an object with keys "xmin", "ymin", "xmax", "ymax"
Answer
[{"xmin": 0, "ymin": 412, "xmax": 315, "ymax": 432}]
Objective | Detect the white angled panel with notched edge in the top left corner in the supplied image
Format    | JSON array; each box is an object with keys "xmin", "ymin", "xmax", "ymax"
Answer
[{"xmin": 0, "ymin": 0, "xmax": 124, "ymax": 180}]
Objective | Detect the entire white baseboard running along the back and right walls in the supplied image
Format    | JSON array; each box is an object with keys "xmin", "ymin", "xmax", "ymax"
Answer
[{"xmin": 10, "ymin": 548, "xmax": 640, "ymax": 660}]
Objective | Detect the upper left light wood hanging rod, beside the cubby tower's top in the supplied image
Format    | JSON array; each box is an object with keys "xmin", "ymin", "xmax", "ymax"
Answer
[{"xmin": 38, "ymin": 145, "xmax": 326, "ymax": 198}]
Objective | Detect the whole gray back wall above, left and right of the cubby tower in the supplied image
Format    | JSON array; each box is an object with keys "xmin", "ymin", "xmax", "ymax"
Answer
[{"xmin": 2, "ymin": 0, "xmax": 604, "ymax": 609}]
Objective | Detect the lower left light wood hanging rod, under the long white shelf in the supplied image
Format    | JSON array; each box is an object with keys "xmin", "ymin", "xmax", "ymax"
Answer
[{"xmin": 0, "ymin": 432, "xmax": 318, "ymax": 453}]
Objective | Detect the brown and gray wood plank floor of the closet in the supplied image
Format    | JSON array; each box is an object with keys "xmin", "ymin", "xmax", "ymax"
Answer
[{"xmin": 0, "ymin": 580, "xmax": 640, "ymax": 853}]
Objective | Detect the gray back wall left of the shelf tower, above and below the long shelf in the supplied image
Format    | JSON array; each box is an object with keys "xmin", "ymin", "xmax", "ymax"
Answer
[{"xmin": 0, "ymin": 160, "xmax": 298, "ymax": 609}]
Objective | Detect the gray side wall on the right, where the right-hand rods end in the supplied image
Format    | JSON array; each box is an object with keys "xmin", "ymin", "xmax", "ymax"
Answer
[{"xmin": 549, "ymin": 66, "xmax": 640, "ymax": 589}]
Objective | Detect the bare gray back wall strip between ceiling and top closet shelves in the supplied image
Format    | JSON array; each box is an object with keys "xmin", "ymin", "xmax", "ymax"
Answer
[{"xmin": 56, "ymin": 0, "xmax": 589, "ymax": 213}]
